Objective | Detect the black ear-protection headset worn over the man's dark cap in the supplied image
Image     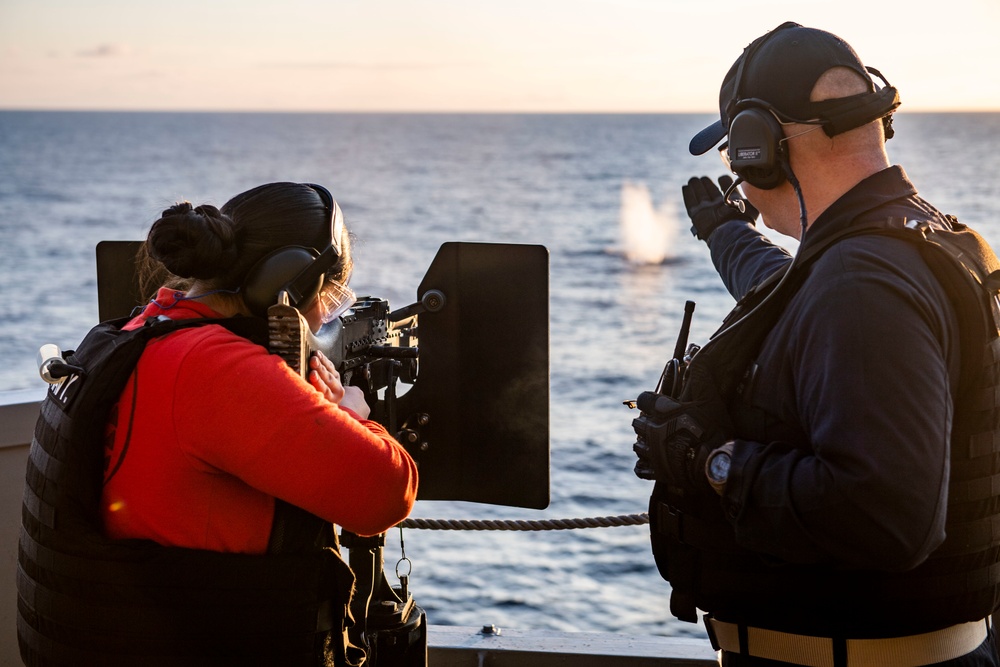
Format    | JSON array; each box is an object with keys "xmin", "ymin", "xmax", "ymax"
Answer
[{"xmin": 724, "ymin": 24, "xmax": 899, "ymax": 190}]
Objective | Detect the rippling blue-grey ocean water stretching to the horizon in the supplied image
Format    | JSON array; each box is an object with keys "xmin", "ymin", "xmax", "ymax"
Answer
[{"xmin": 0, "ymin": 112, "xmax": 1000, "ymax": 636}]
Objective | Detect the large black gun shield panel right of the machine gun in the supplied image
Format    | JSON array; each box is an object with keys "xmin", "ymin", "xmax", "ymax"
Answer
[{"xmin": 398, "ymin": 243, "xmax": 549, "ymax": 509}]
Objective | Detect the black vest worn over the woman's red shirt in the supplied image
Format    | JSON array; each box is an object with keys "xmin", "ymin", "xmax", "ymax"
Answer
[{"xmin": 17, "ymin": 318, "xmax": 360, "ymax": 667}]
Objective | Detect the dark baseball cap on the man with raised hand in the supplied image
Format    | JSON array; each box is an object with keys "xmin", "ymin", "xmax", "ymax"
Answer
[{"xmin": 688, "ymin": 21, "xmax": 899, "ymax": 155}]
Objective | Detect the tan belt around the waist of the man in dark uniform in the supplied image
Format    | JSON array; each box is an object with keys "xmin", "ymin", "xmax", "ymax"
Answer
[{"xmin": 705, "ymin": 616, "xmax": 989, "ymax": 667}]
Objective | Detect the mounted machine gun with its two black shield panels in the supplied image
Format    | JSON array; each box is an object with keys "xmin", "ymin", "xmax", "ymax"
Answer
[{"xmin": 97, "ymin": 241, "xmax": 549, "ymax": 509}]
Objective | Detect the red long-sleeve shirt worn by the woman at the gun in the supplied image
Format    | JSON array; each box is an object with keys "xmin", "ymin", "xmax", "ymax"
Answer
[{"xmin": 101, "ymin": 289, "xmax": 417, "ymax": 553}]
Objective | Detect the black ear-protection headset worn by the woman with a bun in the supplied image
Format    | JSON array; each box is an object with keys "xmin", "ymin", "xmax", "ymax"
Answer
[{"xmin": 241, "ymin": 183, "xmax": 344, "ymax": 317}]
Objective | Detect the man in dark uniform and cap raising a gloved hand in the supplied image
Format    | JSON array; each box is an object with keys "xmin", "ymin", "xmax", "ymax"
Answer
[{"xmin": 635, "ymin": 23, "xmax": 1000, "ymax": 667}]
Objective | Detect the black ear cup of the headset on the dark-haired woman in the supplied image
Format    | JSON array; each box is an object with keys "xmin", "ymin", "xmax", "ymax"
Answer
[{"xmin": 243, "ymin": 246, "xmax": 323, "ymax": 317}]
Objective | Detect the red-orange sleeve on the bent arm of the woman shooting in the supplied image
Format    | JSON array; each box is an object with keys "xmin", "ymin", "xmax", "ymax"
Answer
[{"xmin": 163, "ymin": 326, "xmax": 417, "ymax": 535}]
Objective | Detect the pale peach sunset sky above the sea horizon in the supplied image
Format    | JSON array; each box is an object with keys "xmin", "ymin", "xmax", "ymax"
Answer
[{"xmin": 0, "ymin": 0, "xmax": 1000, "ymax": 112}]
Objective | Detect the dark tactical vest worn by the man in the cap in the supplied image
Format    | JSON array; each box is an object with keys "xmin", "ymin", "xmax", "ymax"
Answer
[{"xmin": 650, "ymin": 218, "xmax": 1000, "ymax": 638}]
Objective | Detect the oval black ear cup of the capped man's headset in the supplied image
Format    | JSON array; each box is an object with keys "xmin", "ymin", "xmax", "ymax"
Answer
[{"xmin": 729, "ymin": 107, "xmax": 787, "ymax": 190}]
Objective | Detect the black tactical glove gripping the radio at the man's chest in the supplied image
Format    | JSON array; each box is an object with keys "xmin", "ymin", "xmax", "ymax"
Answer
[{"xmin": 632, "ymin": 384, "xmax": 732, "ymax": 495}]
